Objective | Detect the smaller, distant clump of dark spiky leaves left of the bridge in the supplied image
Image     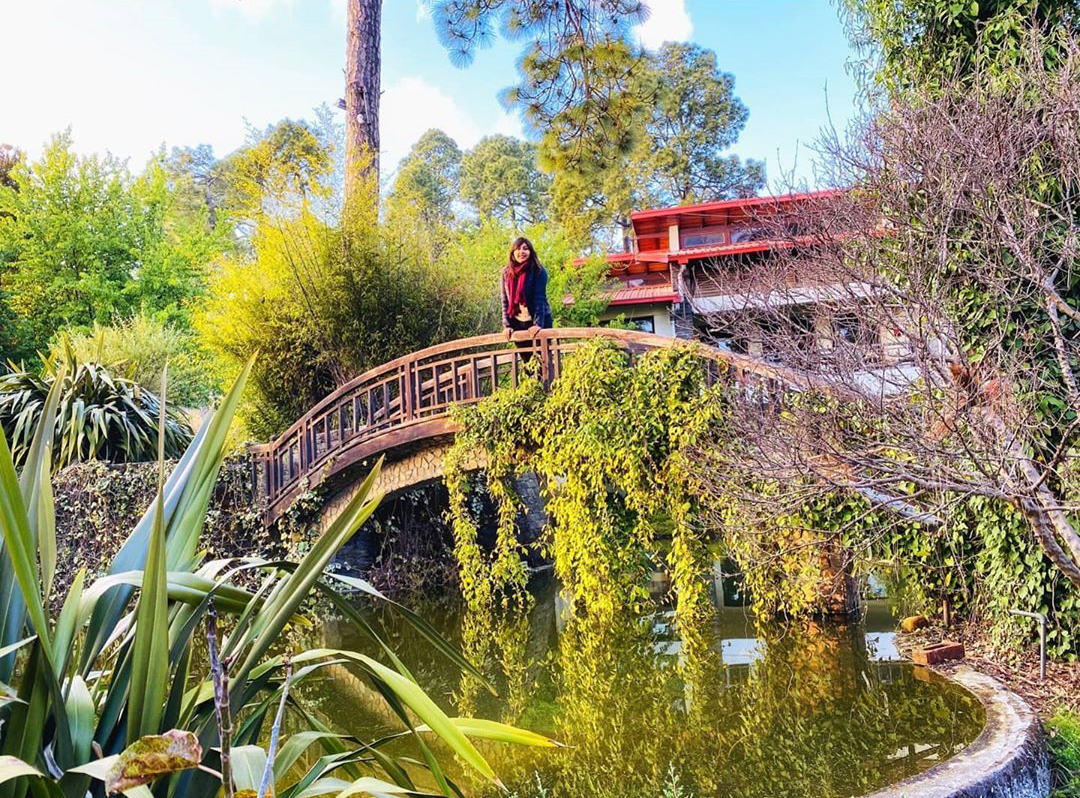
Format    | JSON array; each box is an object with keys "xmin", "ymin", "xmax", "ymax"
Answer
[{"xmin": 0, "ymin": 341, "xmax": 191, "ymax": 469}]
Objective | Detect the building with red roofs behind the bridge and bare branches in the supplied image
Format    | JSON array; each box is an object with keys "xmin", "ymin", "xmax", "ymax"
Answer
[{"xmin": 587, "ymin": 191, "xmax": 902, "ymax": 360}]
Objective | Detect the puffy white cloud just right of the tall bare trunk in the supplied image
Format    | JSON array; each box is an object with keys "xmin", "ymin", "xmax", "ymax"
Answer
[{"xmin": 379, "ymin": 77, "xmax": 522, "ymax": 175}]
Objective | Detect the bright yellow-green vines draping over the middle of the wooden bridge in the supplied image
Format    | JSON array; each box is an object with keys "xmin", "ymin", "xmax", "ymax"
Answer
[{"xmin": 446, "ymin": 340, "xmax": 723, "ymax": 639}]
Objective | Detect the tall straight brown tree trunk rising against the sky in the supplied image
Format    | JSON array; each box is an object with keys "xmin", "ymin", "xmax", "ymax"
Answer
[{"xmin": 345, "ymin": 0, "xmax": 382, "ymax": 217}]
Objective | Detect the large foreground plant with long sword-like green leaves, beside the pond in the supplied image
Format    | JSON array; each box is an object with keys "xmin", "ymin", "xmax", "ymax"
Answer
[{"xmin": 0, "ymin": 364, "xmax": 553, "ymax": 798}]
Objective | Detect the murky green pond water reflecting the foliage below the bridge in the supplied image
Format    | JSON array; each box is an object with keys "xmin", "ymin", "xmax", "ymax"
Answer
[{"xmin": 306, "ymin": 579, "xmax": 984, "ymax": 798}]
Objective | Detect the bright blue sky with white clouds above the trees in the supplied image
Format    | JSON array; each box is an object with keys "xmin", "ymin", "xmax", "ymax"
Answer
[{"xmin": 0, "ymin": 0, "xmax": 854, "ymax": 192}]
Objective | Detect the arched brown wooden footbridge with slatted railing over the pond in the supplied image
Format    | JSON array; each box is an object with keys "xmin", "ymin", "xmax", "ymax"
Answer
[{"xmin": 252, "ymin": 327, "xmax": 779, "ymax": 523}]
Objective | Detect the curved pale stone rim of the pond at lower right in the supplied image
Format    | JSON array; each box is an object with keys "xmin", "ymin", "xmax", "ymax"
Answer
[{"xmin": 864, "ymin": 667, "xmax": 1050, "ymax": 798}]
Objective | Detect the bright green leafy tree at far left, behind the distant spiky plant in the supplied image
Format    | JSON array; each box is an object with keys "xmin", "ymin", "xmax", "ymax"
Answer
[{"xmin": 0, "ymin": 132, "xmax": 227, "ymax": 357}]
